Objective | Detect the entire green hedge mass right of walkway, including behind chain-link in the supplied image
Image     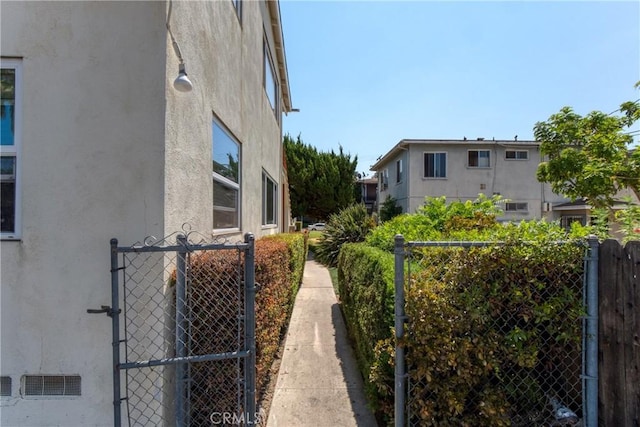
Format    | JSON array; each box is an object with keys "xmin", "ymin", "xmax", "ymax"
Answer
[{"xmin": 338, "ymin": 221, "xmax": 591, "ymax": 426}]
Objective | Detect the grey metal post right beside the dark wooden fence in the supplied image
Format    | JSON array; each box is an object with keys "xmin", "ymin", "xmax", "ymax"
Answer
[{"xmin": 583, "ymin": 236, "xmax": 599, "ymax": 427}]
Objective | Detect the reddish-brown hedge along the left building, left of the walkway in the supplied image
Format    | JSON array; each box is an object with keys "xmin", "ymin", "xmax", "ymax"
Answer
[{"xmin": 182, "ymin": 233, "xmax": 306, "ymax": 418}]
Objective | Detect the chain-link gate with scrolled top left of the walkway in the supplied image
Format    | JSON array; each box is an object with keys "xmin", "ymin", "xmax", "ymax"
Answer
[{"xmin": 91, "ymin": 234, "xmax": 259, "ymax": 427}]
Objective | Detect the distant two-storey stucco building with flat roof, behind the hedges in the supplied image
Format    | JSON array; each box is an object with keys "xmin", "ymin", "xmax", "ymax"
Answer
[{"xmin": 371, "ymin": 138, "xmax": 568, "ymax": 221}]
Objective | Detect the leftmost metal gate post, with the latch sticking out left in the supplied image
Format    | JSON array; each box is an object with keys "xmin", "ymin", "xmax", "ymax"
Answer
[{"xmin": 110, "ymin": 239, "xmax": 122, "ymax": 427}]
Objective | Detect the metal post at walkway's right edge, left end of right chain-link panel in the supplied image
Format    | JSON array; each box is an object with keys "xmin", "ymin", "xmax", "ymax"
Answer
[{"xmin": 393, "ymin": 234, "xmax": 406, "ymax": 427}]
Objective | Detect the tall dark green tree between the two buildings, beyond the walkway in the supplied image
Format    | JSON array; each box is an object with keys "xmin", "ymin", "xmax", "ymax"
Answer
[{"xmin": 284, "ymin": 135, "xmax": 358, "ymax": 219}]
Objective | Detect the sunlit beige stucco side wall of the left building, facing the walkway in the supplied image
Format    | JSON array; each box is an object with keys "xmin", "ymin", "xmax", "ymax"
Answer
[{"xmin": 165, "ymin": 1, "xmax": 282, "ymax": 237}]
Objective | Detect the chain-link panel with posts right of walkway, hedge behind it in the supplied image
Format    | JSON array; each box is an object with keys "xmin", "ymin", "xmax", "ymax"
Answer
[{"xmin": 395, "ymin": 236, "xmax": 598, "ymax": 427}]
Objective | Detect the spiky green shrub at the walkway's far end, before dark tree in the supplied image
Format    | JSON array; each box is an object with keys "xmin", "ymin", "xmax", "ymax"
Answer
[{"xmin": 315, "ymin": 204, "xmax": 375, "ymax": 267}]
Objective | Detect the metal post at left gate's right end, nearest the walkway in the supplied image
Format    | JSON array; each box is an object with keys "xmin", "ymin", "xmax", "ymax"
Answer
[{"xmin": 244, "ymin": 233, "xmax": 256, "ymax": 426}]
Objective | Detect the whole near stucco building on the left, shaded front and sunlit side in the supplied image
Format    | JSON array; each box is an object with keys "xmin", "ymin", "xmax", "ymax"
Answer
[{"xmin": 0, "ymin": 0, "xmax": 292, "ymax": 426}]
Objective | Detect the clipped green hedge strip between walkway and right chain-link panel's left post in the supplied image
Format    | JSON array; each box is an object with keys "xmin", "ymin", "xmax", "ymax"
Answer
[{"xmin": 338, "ymin": 243, "xmax": 394, "ymax": 414}]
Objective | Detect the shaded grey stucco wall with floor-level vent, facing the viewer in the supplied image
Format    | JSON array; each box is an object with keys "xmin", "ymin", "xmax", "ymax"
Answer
[{"xmin": 0, "ymin": 2, "xmax": 167, "ymax": 426}]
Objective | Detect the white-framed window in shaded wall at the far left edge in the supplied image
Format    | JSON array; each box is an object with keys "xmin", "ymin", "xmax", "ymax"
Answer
[{"xmin": 0, "ymin": 59, "xmax": 22, "ymax": 239}]
